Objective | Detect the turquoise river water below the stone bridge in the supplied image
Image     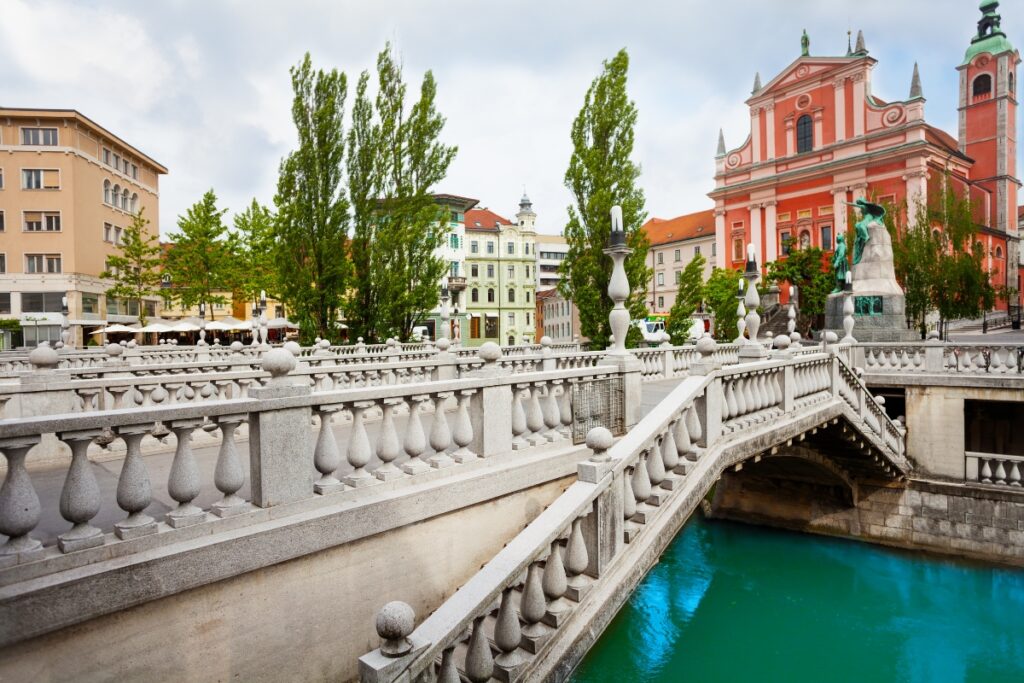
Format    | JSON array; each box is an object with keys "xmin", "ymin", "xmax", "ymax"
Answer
[{"xmin": 572, "ymin": 515, "xmax": 1024, "ymax": 683}]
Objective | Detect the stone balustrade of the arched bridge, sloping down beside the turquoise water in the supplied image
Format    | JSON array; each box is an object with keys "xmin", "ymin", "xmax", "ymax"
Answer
[{"xmin": 359, "ymin": 347, "xmax": 906, "ymax": 683}]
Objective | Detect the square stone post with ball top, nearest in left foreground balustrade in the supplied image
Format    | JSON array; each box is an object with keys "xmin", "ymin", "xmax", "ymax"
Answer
[{"xmin": 249, "ymin": 348, "xmax": 316, "ymax": 508}]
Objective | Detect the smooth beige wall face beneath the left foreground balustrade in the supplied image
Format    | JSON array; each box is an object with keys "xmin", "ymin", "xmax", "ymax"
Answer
[{"xmin": 0, "ymin": 476, "xmax": 575, "ymax": 683}]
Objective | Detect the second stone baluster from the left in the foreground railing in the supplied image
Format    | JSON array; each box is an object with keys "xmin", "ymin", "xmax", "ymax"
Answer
[{"xmin": 57, "ymin": 429, "xmax": 103, "ymax": 553}]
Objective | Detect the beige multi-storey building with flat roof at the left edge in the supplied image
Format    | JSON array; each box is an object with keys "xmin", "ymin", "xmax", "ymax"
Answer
[{"xmin": 0, "ymin": 109, "xmax": 167, "ymax": 346}]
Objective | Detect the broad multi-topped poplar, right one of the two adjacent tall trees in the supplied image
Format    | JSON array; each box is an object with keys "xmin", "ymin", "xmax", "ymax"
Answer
[{"xmin": 360, "ymin": 44, "xmax": 458, "ymax": 340}]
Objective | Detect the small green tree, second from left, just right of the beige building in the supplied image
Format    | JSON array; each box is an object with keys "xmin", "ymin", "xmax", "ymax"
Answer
[{"xmin": 165, "ymin": 189, "xmax": 238, "ymax": 318}]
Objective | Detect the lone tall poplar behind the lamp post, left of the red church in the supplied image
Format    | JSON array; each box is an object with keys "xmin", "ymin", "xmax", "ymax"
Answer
[{"xmin": 558, "ymin": 49, "xmax": 651, "ymax": 348}]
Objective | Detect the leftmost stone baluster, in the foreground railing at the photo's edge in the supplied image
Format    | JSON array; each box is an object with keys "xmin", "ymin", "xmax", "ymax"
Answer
[{"xmin": 0, "ymin": 437, "xmax": 43, "ymax": 566}]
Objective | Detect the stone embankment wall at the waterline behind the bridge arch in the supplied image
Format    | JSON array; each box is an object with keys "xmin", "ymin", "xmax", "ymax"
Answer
[{"xmin": 711, "ymin": 471, "xmax": 1024, "ymax": 566}]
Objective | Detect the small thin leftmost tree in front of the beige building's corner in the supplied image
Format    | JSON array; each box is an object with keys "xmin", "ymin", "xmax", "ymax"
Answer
[{"xmin": 99, "ymin": 209, "xmax": 163, "ymax": 327}]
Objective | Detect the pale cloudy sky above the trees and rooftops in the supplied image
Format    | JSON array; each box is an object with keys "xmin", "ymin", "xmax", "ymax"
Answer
[{"xmin": 0, "ymin": 0, "xmax": 1024, "ymax": 234}]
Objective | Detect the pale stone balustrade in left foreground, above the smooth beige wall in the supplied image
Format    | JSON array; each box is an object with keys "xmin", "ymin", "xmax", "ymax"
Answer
[{"xmin": 0, "ymin": 346, "xmax": 629, "ymax": 584}]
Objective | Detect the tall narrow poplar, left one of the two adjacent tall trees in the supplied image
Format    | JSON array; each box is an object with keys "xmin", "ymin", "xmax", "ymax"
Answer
[{"xmin": 273, "ymin": 53, "xmax": 349, "ymax": 342}]
